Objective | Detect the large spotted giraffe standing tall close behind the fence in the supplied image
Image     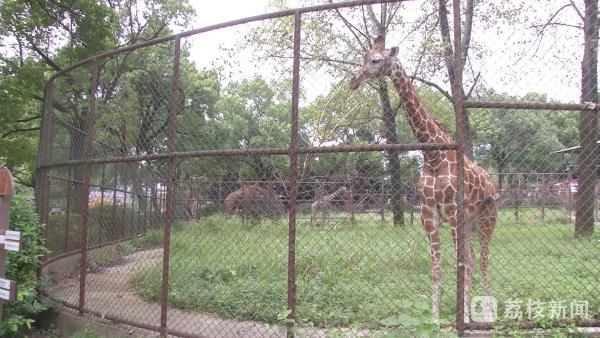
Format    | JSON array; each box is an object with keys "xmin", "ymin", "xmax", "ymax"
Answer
[{"xmin": 350, "ymin": 36, "xmax": 498, "ymax": 322}]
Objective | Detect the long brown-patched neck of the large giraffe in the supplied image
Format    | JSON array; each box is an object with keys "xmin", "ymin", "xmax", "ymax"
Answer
[{"xmin": 389, "ymin": 60, "xmax": 452, "ymax": 171}]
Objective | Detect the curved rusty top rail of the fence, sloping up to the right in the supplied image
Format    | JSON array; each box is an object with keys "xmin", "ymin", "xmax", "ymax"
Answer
[{"xmin": 49, "ymin": 0, "xmax": 411, "ymax": 81}]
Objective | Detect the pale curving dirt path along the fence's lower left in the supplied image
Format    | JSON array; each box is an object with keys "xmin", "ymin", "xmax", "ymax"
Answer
[{"xmin": 46, "ymin": 249, "xmax": 372, "ymax": 338}]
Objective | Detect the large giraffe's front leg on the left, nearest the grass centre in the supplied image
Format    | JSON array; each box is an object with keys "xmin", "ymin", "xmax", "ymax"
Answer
[{"xmin": 421, "ymin": 205, "xmax": 442, "ymax": 319}]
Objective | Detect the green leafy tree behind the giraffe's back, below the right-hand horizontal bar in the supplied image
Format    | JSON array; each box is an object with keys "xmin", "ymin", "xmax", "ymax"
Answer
[{"xmin": 471, "ymin": 91, "xmax": 577, "ymax": 191}]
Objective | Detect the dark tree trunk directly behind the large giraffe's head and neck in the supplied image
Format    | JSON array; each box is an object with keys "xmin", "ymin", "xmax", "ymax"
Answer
[{"xmin": 377, "ymin": 80, "xmax": 406, "ymax": 226}]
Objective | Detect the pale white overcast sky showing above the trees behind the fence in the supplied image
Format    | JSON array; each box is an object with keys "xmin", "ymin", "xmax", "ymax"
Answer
[{"xmin": 186, "ymin": 0, "xmax": 582, "ymax": 102}]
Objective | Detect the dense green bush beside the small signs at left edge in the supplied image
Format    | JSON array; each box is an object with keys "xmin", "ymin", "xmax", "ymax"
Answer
[{"xmin": 0, "ymin": 197, "xmax": 48, "ymax": 337}]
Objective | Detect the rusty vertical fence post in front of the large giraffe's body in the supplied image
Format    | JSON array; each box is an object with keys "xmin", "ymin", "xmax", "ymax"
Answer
[{"xmin": 451, "ymin": 0, "xmax": 470, "ymax": 334}]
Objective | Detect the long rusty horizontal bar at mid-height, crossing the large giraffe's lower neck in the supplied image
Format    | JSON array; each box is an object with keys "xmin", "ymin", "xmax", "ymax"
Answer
[{"xmin": 38, "ymin": 143, "xmax": 457, "ymax": 169}]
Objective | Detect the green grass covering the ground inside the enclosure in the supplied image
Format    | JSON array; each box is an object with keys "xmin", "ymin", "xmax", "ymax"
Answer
[{"xmin": 133, "ymin": 209, "xmax": 600, "ymax": 327}]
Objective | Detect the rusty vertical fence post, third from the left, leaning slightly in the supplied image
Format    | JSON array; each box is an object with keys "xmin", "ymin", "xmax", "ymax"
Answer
[{"xmin": 160, "ymin": 38, "xmax": 181, "ymax": 336}]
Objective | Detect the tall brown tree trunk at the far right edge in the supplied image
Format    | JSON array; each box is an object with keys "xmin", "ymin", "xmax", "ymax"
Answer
[{"xmin": 575, "ymin": 0, "xmax": 598, "ymax": 236}]
